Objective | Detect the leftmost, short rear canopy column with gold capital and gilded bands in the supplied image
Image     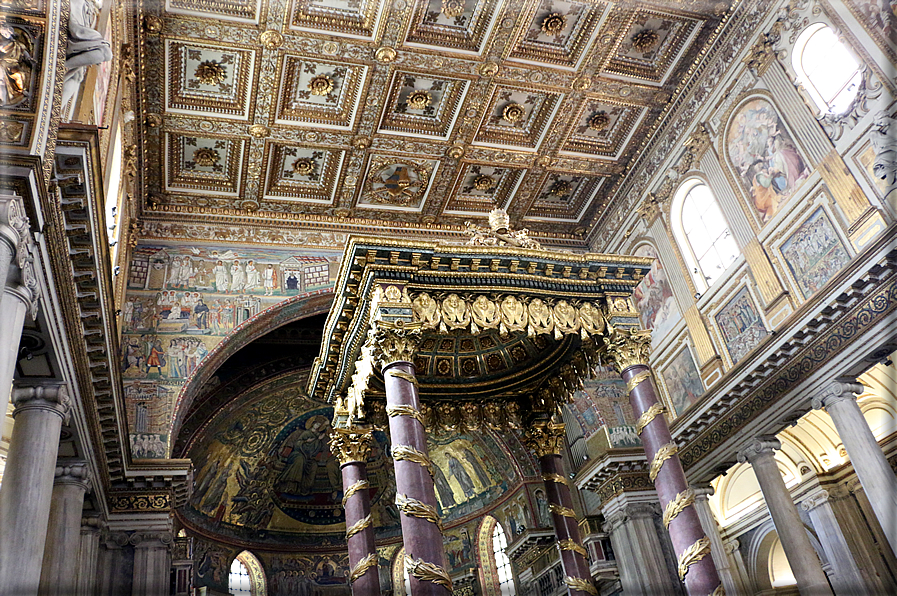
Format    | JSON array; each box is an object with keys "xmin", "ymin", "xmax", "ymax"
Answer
[{"xmin": 330, "ymin": 427, "xmax": 380, "ymax": 596}]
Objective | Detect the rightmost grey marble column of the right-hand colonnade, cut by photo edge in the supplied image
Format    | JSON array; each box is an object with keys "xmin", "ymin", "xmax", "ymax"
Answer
[{"xmin": 813, "ymin": 379, "xmax": 897, "ymax": 553}]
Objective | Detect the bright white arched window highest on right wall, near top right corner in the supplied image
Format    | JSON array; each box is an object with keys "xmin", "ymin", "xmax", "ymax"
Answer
[{"xmin": 791, "ymin": 23, "xmax": 863, "ymax": 114}]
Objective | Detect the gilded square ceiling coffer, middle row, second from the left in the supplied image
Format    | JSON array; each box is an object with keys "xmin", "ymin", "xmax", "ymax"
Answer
[{"xmin": 275, "ymin": 55, "xmax": 368, "ymax": 129}]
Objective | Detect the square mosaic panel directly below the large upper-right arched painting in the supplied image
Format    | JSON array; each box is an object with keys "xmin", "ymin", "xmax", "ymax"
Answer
[{"xmin": 782, "ymin": 207, "xmax": 850, "ymax": 298}]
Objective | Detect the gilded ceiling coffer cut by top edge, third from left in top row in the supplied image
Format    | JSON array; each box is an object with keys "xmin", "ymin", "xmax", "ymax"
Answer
[{"xmin": 405, "ymin": 0, "xmax": 503, "ymax": 54}]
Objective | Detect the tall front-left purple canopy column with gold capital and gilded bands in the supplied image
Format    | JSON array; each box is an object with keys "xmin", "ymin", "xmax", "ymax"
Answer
[{"xmin": 374, "ymin": 321, "xmax": 452, "ymax": 596}]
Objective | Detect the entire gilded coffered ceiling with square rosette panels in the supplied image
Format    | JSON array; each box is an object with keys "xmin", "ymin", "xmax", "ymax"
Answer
[{"xmin": 134, "ymin": 0, "xmax": 730, "ymax": 242}]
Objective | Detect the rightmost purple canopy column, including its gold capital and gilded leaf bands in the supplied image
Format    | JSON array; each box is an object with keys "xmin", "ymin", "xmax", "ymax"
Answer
[{"xmin": 604, "ymin": 329, "xmax": 722, "ymax": 596}]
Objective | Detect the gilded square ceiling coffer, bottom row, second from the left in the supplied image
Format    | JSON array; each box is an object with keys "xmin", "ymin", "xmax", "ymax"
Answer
[{"xmin": 265, "ymin": 143, "xmax": 346, "ymax": 205}]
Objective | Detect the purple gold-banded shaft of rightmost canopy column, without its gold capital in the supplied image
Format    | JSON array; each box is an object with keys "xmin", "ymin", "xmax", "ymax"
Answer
[{"xmin": 621, "ymin": 364, "xmax": 722, "ymax": 596}]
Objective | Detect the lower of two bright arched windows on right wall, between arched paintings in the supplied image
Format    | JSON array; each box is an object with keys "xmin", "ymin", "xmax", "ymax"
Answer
[{"xmin": 672, "ymin": 178, "xmax": 739, "ymax": 292}]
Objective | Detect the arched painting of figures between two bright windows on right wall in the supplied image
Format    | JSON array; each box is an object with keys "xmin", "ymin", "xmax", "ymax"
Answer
[{"xmin": 726, "ymin": 98, "xmax": 810, "ymax": 223}]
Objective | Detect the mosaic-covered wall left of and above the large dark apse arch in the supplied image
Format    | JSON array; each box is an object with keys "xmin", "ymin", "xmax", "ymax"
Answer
[{"xmin": 121, "ymin": 242, "xmax": 341, "ymax": 459}]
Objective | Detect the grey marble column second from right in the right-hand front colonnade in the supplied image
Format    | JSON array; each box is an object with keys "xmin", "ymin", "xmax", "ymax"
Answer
[{"xmin": 738, "ymin": 437, "xmax": 832, "ymax": 596}]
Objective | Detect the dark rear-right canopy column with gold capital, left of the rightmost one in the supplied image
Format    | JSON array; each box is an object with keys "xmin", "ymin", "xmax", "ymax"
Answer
[{"xmin": 525, "ymin": 420, "xmax": 598, "ymax": 596}]
